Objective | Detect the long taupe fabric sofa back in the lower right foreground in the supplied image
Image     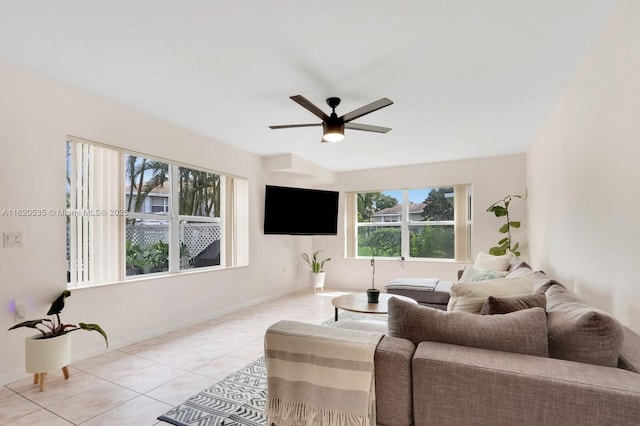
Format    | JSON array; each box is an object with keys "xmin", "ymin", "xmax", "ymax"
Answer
[{"xmin": 412, "ymin": 342, "xmax": 640, "ymax": 426}]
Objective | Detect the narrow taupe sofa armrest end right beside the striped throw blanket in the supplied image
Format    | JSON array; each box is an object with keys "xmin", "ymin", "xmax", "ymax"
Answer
[{"xmin": 375, "ymin": 336, "xmax": 416, "ymax": 426}]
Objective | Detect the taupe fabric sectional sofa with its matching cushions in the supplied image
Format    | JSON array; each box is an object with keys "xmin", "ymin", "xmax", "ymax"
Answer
[{"xmin": 280, "ymin": 261, "xmax": 640, "ymax": 426}]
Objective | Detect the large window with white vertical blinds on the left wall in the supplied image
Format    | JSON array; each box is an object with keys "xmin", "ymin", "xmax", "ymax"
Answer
[{"xmin": 66, "ymin": 137, "xmax": 248, "ymax": 287}]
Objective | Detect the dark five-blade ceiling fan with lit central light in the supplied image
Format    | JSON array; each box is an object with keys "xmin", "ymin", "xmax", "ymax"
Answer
[{"xmin": 269, "ymin": 95, "xmax": 393, "ymax": 142}]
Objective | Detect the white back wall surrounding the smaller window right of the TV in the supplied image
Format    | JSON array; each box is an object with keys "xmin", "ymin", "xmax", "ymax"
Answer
[{"xmin": 313, "ymin": 154, "xmax": 528, "ymax": 291}]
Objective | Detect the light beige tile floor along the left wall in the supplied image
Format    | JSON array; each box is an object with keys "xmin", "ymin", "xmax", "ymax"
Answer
[{"xmin": 0, "ymin": 290, "xmax": 347, "ymax": 426}]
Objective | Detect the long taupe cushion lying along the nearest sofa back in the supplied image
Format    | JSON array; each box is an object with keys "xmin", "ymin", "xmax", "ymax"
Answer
[{"xmin": 388, "ymin": 298, "xmax": 549, "ymax": 357}]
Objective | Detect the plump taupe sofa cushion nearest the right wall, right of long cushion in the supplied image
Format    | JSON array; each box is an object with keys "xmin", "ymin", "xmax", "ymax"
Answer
[{"xmin": 546, "ymin": 285, "xmax": 624, "ymax": 367}]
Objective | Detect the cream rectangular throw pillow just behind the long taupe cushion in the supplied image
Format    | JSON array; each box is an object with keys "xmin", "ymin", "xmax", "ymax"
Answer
[{"xmin": 447, "ymin": 277, "xmax": 533, "ymax": 314}]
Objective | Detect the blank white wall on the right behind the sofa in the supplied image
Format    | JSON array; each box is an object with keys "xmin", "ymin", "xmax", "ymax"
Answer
[{"xmin": 527, "ymin": 0, "xmax": 640, "ymax": 331}]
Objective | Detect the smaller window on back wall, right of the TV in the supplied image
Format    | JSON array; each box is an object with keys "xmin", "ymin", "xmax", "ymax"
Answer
[{"xmin": 347, "ymin": 185, "xmax": 471, "ymax": 261}]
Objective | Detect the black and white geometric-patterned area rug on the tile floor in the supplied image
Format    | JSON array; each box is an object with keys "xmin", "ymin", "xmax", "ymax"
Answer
[{"xmin": 158, "ymin": 311, "xmax": 387, "ymax": 426}]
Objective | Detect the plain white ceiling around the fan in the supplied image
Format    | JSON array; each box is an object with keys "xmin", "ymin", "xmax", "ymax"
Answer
[{"xmin": 0, "ymin": 0, "xmax": 616, "ymax": 171}]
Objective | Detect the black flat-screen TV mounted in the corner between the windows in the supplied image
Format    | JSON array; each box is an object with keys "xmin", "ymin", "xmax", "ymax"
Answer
[{"xmin": 264, "ymin": 185, "xmax": 339, "ymax": 235}]
